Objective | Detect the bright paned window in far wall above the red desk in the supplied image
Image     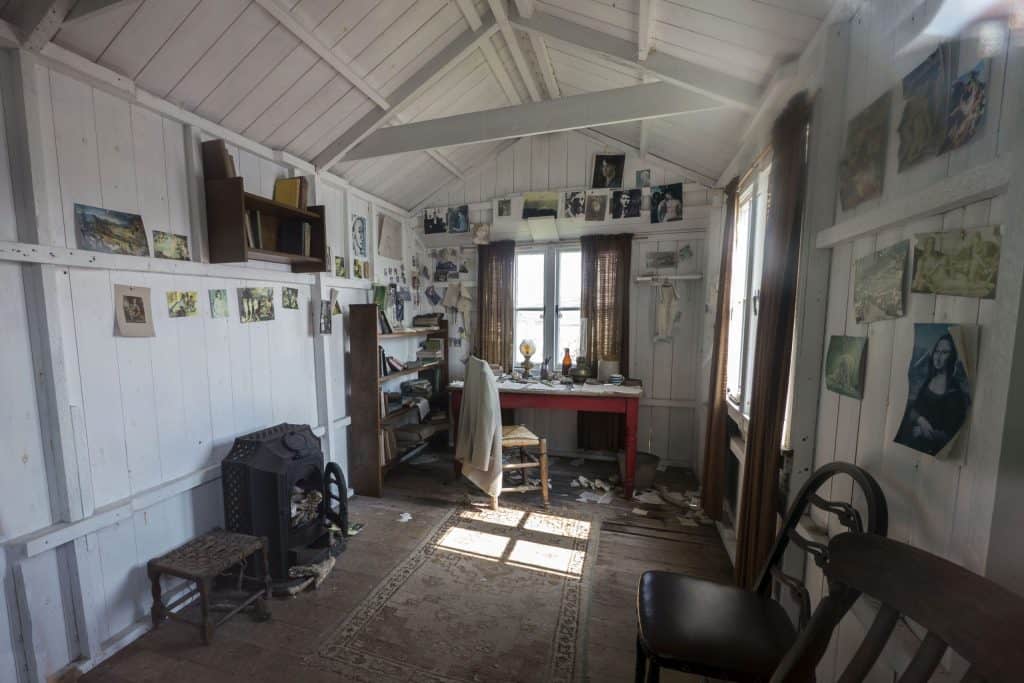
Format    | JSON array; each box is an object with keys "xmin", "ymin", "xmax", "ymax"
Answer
[{"xmin": 513, "ymin": 245, "xmax": 583, "ymax": 368}]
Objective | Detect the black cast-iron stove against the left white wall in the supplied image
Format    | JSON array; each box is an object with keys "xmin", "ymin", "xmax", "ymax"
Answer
[{"xmin": 220, "ymin": 424, "xmax": 348, "ymax": 588}]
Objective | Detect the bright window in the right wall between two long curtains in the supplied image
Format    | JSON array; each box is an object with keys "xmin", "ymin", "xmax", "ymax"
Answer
[{"xmin": 726, "ymin": 161, "xmax": 771, "ymax": 416}]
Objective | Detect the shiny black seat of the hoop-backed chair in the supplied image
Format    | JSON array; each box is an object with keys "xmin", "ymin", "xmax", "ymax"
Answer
[{"xmin": 637, "ymin": 571, "xmax": 797, "ymax": 680}]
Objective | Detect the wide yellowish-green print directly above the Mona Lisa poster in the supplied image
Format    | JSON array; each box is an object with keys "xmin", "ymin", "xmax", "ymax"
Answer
[{"xmin": 910, "ymin": 225, "xmax": 1001, "ymax": 299}]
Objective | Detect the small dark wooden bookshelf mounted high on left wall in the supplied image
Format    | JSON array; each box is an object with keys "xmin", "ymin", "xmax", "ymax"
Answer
[{"xmin": 197, "ymin": 140, "xmax": 328, "ymax": 272}]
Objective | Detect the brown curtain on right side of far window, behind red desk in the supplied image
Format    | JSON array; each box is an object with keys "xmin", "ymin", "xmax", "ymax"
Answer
[{"xmin": 577, "ymin": 234, "xmax": 633, "ymax": 451}]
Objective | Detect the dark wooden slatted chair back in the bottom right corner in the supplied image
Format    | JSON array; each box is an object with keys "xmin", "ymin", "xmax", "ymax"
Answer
[{"xmin": 771, "ymin": 533, "xmax": 1024, "ymax": 683}]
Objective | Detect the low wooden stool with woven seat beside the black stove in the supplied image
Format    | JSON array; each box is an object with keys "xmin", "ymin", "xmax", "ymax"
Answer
[{"xmin": 146, "ymin": 529, "xmax": 270, "ymax": 645}]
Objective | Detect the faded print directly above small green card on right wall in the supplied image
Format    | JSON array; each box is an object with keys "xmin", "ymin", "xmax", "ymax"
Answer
[{"xmin": 853, "ymin": 240, "xmax": 910, "ymax": 323}]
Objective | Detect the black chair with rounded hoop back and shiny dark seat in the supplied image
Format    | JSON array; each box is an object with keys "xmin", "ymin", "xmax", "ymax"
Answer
[{"xmin": 636, "ymin": 463, "xmax": 888, "ymax": 683}]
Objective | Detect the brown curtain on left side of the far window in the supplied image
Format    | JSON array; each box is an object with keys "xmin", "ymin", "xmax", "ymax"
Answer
[{"xmin": 474, "ymin": 241, "xmax": 515, "ymax": 372}]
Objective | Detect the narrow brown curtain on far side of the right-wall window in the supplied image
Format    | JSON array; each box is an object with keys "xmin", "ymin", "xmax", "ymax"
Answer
[{"xmin": 700, "ymin": 178, "xmax": 739, "ymax": 521}]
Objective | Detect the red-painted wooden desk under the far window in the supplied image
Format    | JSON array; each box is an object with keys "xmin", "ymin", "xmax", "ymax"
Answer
[{"xmin": 449, "ymin": 385, "xmax": 641, "ymax": 500}]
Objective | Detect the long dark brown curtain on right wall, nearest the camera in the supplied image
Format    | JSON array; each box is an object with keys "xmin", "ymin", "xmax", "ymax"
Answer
[{"xmin": 736, "ymin": 93, "xmax": 811, "ymax": 590}]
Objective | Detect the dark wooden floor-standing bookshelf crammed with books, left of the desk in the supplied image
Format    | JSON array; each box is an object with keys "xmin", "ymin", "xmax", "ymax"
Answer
[{"xmin": 348, "ymin": 303, "xmax": 449, "ymax": 496}]
